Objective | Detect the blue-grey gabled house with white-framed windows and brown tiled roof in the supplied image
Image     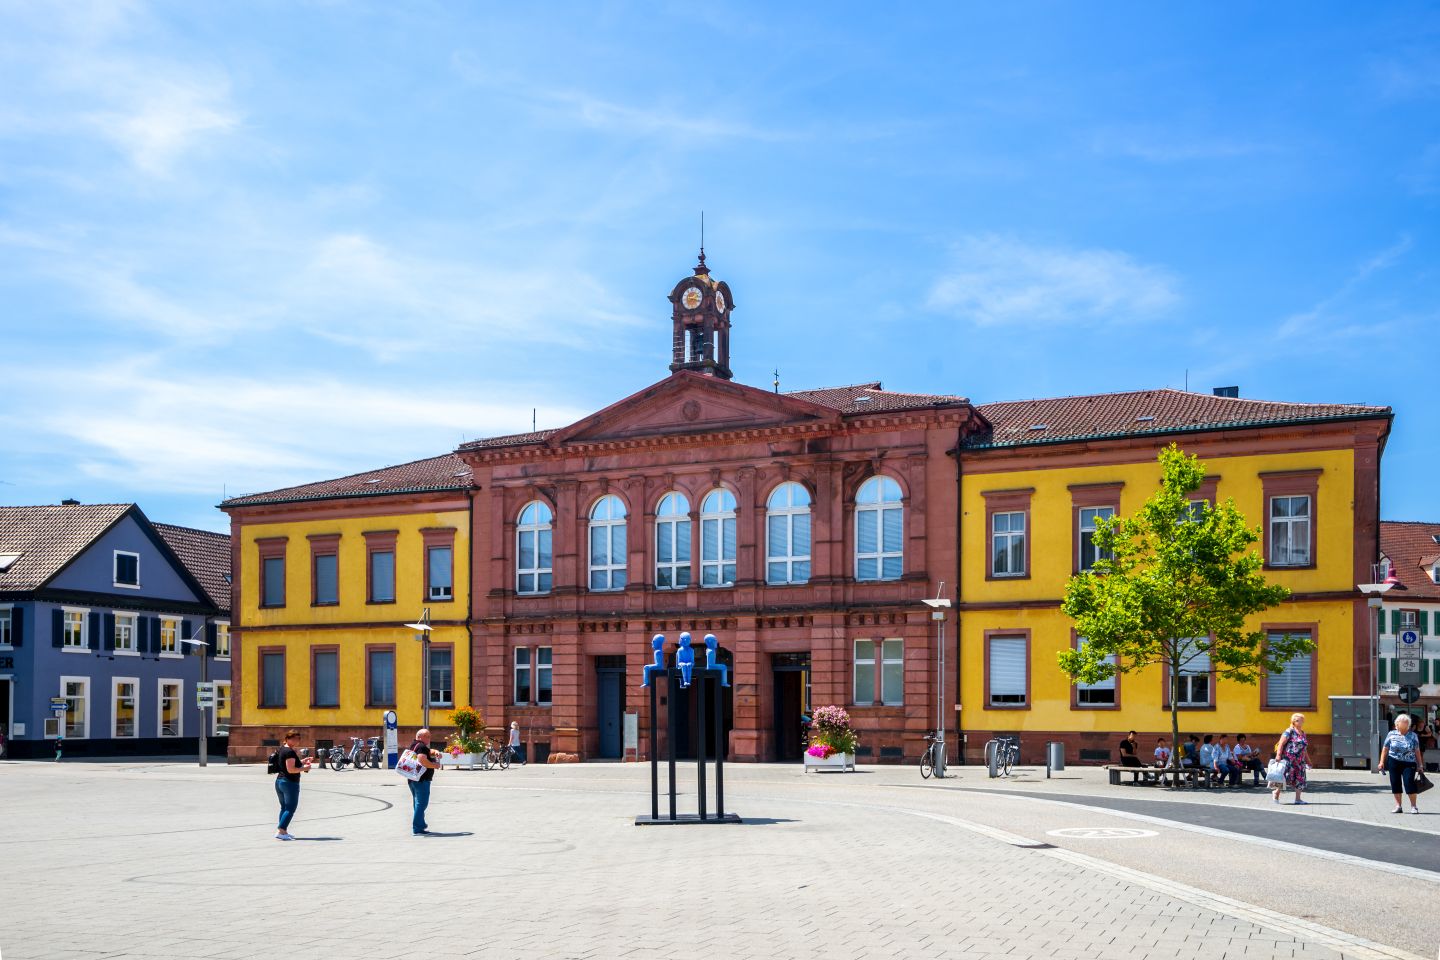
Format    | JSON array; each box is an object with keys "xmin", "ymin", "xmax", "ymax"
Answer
[{"xmin": 0, "ymin": 501, "xmax": 230, "ymax": 759}]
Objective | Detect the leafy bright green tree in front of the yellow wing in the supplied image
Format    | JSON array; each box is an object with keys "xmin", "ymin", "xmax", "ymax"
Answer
[{"xmin": 1060, "ymin": 443, "xmax": 1315, "ymax": 770}]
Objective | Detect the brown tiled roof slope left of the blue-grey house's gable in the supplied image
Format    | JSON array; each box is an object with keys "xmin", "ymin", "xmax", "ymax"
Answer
[{"xmin": 0, "ymin": 504, "xmax": 134, "ymax": 590}]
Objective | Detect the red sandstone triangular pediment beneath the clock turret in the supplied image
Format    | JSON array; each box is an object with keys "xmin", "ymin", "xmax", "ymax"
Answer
[{"xmin": 547, "ymin": 371, "xmax": 840, "ymax": 445}]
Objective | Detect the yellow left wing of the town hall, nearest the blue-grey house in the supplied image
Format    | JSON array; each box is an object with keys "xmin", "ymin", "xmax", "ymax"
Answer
[{"xmin": 222, "ymin": 455, "xmax": 472, "ymax": 760}]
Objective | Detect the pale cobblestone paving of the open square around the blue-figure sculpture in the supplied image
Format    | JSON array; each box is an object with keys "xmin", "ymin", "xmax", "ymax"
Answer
[{"xmin": 0, "ymin": 763, "xmax": 1430, "ymax": 960}]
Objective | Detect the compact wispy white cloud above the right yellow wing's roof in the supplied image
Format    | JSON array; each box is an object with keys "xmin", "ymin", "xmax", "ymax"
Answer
[{"xmin": 927, "ymin": 235, "xmax": 1179, "ymax": 327}]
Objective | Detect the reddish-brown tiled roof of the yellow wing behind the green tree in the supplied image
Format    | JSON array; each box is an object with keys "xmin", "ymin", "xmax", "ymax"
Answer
[{"xmin": 965, "ymin": 389, "xmax": 1390, "ymax": 448}]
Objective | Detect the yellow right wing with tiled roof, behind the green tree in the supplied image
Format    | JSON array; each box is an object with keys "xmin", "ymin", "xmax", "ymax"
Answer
[{"xmin": 958, "ymin": 390, "xmax": 1390, "ymax": 764}]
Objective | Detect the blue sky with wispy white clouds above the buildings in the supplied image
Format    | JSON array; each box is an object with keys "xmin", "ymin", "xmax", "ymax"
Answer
[{"xmin": 0, "ymin": 0, "xmax": 1440, "ymax": 530}]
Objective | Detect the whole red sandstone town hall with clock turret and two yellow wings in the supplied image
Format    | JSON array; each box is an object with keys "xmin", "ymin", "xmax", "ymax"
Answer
[{"xmin": 222, "ymin": 256, "xmax": 1391, "ymax": 763}]
